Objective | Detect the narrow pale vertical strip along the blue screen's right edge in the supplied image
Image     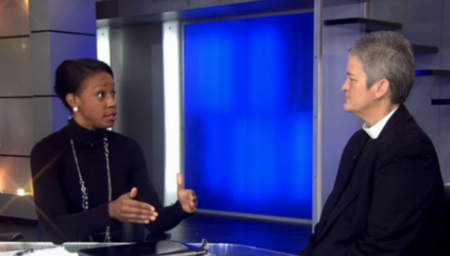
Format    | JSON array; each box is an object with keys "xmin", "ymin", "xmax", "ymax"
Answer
[{"xmin": 312, "ymin": 0, "xmax": 323, "ymax": 228}]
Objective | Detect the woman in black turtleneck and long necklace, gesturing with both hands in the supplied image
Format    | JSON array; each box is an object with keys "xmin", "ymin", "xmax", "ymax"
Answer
[{"xmin": 31, "ymin": 59, "xmax": 197, "ymax": 243}]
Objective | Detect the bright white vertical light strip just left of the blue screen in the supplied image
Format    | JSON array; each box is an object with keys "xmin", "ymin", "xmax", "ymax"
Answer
[{"xmin": 163, "ymin": 21, "xmax": 181, "ymax": 205}]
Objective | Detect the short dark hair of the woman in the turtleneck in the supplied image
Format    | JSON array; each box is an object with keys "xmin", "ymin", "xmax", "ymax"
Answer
[{"xmin": 54, "ymin": 59, "xmax": 114, "ymax": 111}]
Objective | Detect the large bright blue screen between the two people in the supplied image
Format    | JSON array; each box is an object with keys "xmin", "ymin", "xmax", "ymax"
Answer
[{"xmin": 184, "ymin": 13, "xmax": 314, "ymax": 219}]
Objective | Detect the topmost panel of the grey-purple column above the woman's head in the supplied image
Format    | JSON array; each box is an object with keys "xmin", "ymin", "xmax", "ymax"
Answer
[{"xmin": 30, "ymin": 0, "xmax": 96, "ymax": 34}]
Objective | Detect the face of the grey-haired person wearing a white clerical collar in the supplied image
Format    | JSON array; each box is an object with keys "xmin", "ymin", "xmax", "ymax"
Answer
[{"xmin": 342, "ymin": 55, "xmax": 375, "ymax": 115}]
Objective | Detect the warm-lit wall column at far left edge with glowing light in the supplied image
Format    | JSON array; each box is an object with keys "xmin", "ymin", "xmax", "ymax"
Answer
[{"xmin": 0, "ymin": 0, "xmax": 35, "ymax": 218}]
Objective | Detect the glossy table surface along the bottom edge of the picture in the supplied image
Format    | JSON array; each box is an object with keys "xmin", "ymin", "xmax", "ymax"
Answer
[{"xmin": 0, "ymin": 242, "xmax": 293, "ymax": 256}]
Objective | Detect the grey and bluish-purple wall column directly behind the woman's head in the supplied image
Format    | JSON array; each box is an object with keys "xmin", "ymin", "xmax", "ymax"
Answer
[{"xmin": 30, "ymin": 0, "xmax": 97, "ymax": 142}]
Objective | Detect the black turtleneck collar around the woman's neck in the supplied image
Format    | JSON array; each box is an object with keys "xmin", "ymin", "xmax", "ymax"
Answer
[{"xmin": 66, "ymin": 118, "xmax": 106, "ymax": 146}]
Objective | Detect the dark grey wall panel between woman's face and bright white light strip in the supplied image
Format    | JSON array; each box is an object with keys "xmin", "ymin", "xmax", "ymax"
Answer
[{"xmin": 111, "ymin": 24, "xmax": 164, "ymax": 199}]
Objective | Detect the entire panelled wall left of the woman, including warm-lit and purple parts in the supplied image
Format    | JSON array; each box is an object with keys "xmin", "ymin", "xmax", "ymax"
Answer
[{"xmin": 0, "ymin": 0, "xmax": 96, "ymax": 219}]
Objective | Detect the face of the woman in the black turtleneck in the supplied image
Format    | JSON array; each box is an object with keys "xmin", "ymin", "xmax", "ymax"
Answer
[{"xmin": 67, "ymin": 72, "xmax": 117, "ymax": 130}]
